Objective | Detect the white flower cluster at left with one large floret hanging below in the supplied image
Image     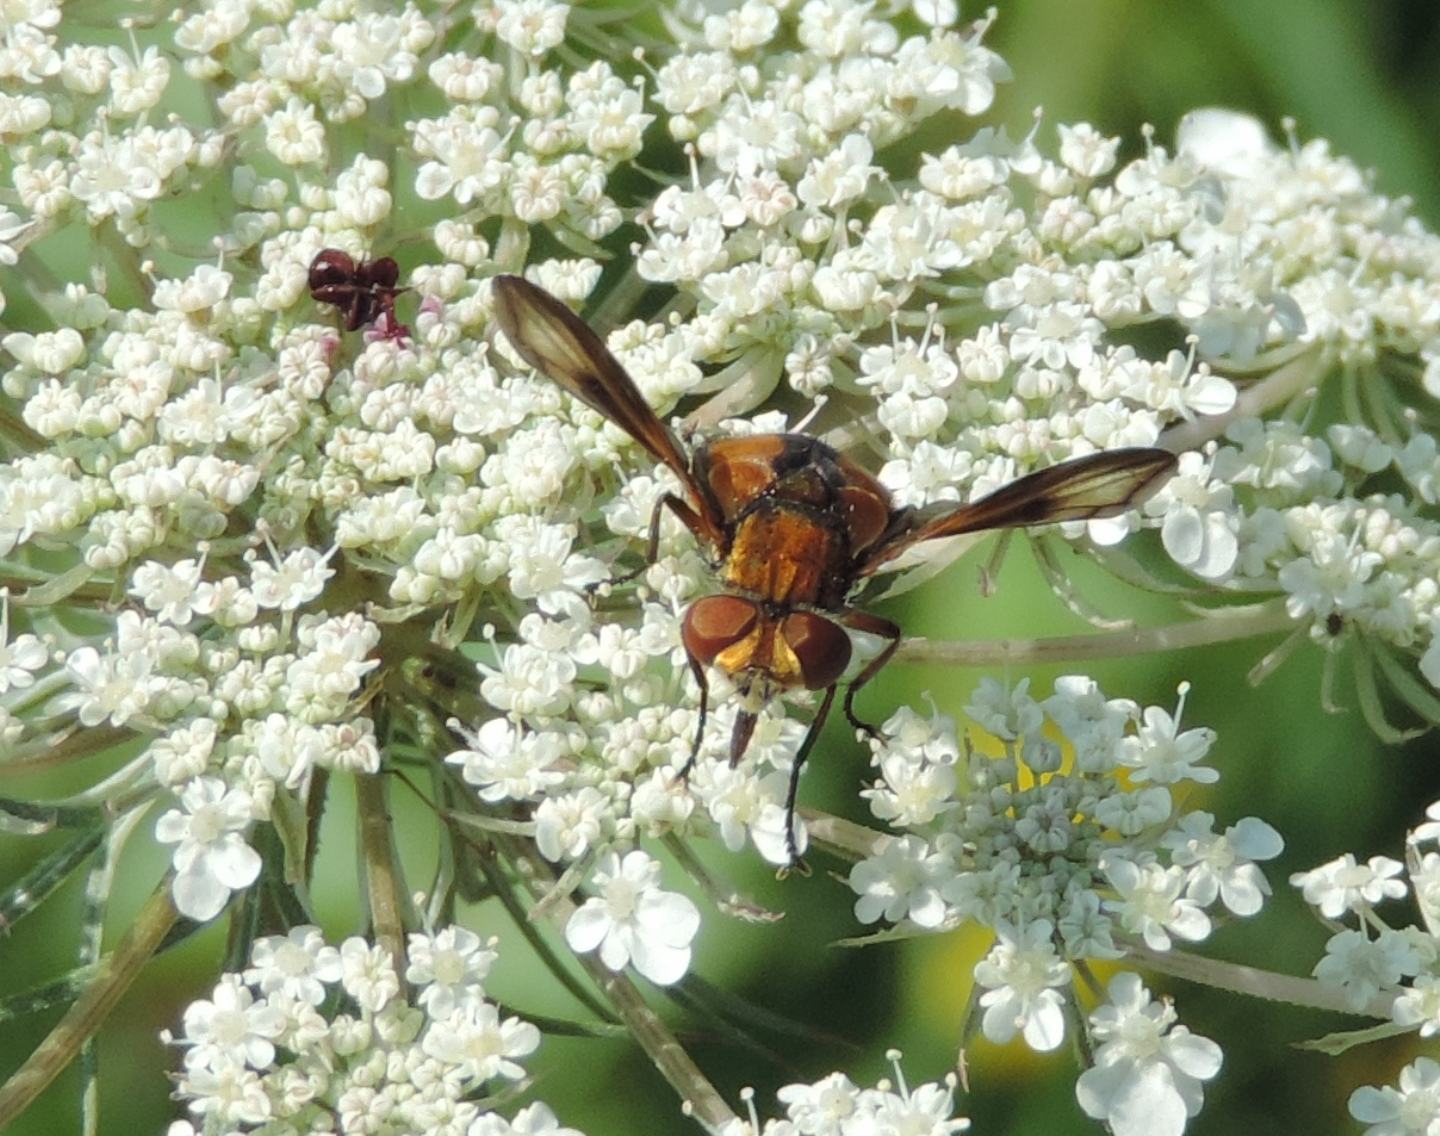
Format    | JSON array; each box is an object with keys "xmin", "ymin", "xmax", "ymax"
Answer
[{"xmin": 53, "ymin": 598, "xmax": 380, "ymax": 920}]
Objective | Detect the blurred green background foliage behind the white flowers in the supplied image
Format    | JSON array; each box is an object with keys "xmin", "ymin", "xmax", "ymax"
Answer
[{"xmin": 8, "ymin": 0, "xmax": 1440, "ymax": 1136}]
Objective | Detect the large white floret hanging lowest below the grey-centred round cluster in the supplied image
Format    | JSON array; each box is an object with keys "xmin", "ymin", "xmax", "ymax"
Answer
[{"xmin": 1076, "ymin": 973, "xmax": 1221, "ymax": 1136}]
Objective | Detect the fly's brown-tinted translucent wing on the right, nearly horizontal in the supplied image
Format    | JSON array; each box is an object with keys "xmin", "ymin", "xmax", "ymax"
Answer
[{"xmin": 857, "ymin": 446, "xmax": 1175, "ymax": 576}]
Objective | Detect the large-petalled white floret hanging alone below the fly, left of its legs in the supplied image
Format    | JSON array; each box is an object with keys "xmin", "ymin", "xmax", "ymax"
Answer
[{"xmin": 564, "ymin": 849, "xmax": 700, "ymax": 986}]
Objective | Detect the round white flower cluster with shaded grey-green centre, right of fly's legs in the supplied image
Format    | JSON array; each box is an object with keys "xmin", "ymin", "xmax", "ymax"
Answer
[{"xmin": 850, "ymin": 677, "xmax": 1282, "ymax": 1132}]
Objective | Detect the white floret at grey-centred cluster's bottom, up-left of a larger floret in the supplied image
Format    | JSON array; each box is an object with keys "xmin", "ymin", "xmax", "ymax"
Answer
[{"xmin": 975, "ymin": 919, "xmax": 1070, "ymax": 1052}]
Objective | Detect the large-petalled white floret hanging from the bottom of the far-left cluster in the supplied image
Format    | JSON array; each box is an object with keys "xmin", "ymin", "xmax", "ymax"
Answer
[{"xmin": 156, "ymin": 777, "xmax": 261, "ymax": 923}]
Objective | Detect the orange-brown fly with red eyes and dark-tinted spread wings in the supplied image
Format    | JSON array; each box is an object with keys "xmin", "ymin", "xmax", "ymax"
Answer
[{"xmin": 494, "ymin": 276, "xmax": 1175, "ymax": 864}]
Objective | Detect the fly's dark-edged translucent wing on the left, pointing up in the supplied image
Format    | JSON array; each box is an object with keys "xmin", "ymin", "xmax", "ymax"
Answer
[{"xmin": 494, "ymin": 276, "xmax": 706, "ymax": 486}]
